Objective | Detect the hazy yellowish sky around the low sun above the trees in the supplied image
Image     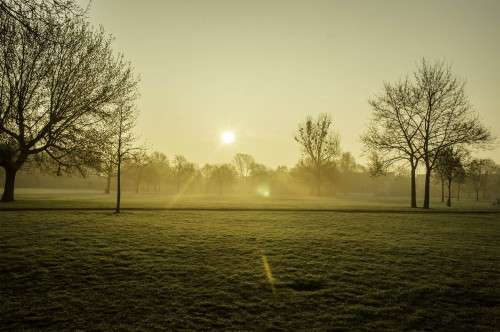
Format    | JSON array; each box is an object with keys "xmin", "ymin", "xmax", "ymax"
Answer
[{"xmin": 81, "ymin": 0, "xmax": 500, "ymax": 166}]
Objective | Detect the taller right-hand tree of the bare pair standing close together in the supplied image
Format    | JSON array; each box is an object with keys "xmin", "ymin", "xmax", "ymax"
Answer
[{"xmin": 415, "ymin": 59, "xmax": 492, "ymax": 209}]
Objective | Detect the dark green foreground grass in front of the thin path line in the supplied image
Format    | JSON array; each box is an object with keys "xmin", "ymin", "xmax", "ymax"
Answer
[{"xmin": 0, "ymin": 211, "xmax": 500, "ymax": 331}]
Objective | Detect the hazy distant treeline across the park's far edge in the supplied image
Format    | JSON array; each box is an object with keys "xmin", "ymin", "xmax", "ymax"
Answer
[{"xmin": 4, "ymin": 152, "xmax": 500, "ymax": 201}]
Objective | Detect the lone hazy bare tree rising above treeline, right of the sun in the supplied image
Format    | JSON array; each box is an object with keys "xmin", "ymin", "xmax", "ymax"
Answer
[{"xmin": 295, "ymin": 114, "xmax": 340, "ymax": 195}]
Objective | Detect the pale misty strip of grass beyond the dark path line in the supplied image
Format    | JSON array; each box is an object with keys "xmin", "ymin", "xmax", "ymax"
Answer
[{"xmin": 0, "ymin": 188, "xmax": 500, "ymax": 212}]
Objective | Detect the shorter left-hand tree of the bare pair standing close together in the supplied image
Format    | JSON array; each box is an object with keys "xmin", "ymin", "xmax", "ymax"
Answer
[{"xmin": 361, "ymin": 79, "xmax": 422, "ymax": 208}]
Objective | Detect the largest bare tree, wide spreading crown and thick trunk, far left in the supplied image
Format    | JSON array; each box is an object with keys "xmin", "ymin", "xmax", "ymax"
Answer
[{"xmin": 0, "ymin": 12, "xmax": 137, "ymax": 201}]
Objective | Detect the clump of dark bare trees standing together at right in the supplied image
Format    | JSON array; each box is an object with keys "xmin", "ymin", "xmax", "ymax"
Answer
[{"xmin": 362, "ymin": 59, "xmax": 493, "ymax": 209}]
